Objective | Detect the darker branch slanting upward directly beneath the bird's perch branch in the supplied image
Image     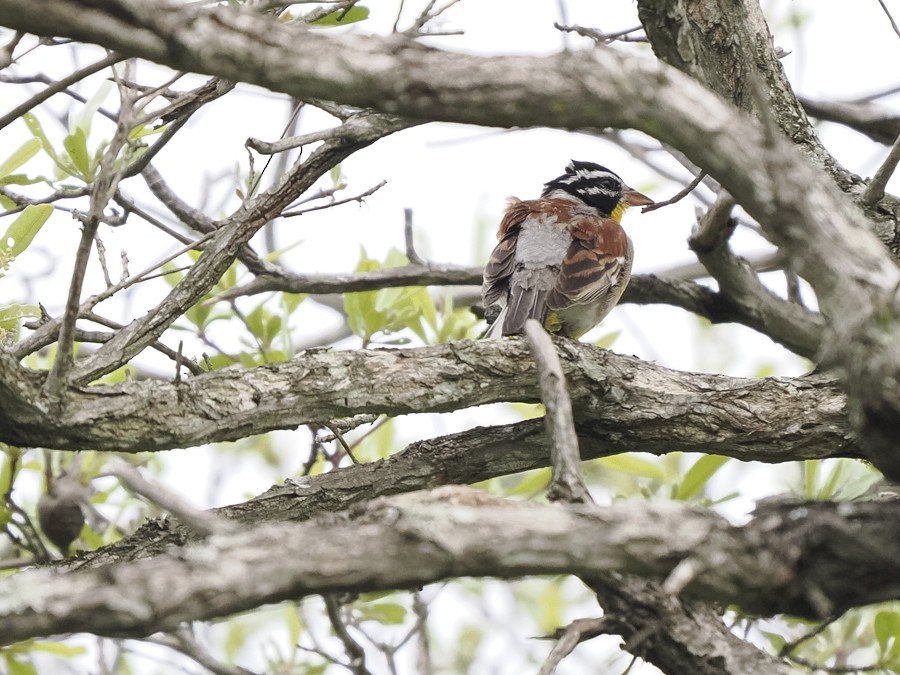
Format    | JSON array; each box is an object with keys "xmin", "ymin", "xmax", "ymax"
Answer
[{"xmin": 61, "ymin": 398, "xmax": 859, "ymax": 568}]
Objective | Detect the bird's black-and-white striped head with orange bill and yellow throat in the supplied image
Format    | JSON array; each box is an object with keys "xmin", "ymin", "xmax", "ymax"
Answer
[{"xmin": 541, "ymin": 159, "xmax": 653, "ymax": 220}]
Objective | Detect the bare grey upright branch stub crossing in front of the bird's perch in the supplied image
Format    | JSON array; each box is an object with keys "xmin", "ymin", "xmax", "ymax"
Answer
[{"xmin": 525, "ymin": 319, "xmax": 594, "ymax": 504}]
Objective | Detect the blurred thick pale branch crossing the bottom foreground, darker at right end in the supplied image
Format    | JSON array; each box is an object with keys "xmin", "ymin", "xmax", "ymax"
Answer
[{"xmin": 0, "ymin": 487, "xmax": 900, "ymax": 644}]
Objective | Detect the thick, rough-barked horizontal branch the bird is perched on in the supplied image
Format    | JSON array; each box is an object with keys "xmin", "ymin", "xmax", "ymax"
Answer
[{"xmin": 0, "ymin": 340, "xmax": 859, "ymax": 461}]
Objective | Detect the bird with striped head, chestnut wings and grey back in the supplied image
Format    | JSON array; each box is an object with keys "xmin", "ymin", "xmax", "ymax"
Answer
[{"xmin": 481, "ymin": 160, "xmax": 654, "ymax": 339}]
